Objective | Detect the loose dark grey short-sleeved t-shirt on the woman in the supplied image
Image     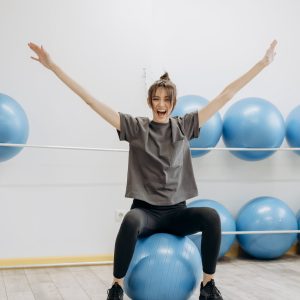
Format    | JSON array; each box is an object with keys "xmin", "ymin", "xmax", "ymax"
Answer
[{"xmin": 118, "ymin": 111, "xmax": 199, "ymax": 205}]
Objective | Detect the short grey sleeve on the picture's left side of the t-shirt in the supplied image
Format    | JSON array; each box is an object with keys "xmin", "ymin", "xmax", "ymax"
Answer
[{"xmin": 117, "ymin": 112, "xmax": 140, "ymax": 142}]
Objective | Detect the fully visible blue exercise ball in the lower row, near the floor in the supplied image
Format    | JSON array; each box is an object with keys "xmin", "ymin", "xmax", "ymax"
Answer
[{"xmin": 236, "ymin": 197, "xmax": 298, "ymax": 259}]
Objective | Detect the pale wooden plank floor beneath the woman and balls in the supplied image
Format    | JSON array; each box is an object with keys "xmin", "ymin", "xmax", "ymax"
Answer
[{"xmin": 0, "ymin": 256, "xmax": 300, "ymax": 300}]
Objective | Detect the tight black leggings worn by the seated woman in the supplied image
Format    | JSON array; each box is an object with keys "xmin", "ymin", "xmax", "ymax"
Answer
[{"xmin": 114, "ymin": 199, "xmax": 221, "ymax": 278}]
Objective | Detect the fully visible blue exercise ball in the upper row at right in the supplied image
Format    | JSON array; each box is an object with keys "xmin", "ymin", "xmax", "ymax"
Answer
[{"xmin": 223, "ymin": 98, "xmax": 285, "ymax": 161}]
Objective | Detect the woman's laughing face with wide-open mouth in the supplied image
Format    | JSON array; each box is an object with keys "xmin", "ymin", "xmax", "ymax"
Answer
[{"xmin": 151, "ymin": 87, "xmax": 173, "ymax": 123}]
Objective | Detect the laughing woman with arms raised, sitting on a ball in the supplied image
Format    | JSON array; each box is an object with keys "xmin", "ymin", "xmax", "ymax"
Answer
[{"xmin": 28, "ymin": 40, "xmax": 277, "ymax": 300}]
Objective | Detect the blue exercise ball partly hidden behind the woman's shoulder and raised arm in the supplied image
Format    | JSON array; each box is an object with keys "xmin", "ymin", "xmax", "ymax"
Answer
[{"xmin": 172, "ymin": 95, "xmax": 222, "ymax": 157}]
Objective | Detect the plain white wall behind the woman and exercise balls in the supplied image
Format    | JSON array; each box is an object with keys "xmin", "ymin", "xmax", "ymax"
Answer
[{"xmin": 0, "ymin": 0, "xmax": 300, "ymax": 258}]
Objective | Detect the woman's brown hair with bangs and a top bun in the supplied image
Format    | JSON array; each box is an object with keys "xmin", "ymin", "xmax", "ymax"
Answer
[{"xmin": 148, "ymin": 72, "xmax": 177, "ymax": 110}]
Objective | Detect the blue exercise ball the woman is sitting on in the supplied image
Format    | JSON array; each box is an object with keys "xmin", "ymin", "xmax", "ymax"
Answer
[{"xmin": 124, "ymin": 233, "xmax": 202, "ymax": 300}]
